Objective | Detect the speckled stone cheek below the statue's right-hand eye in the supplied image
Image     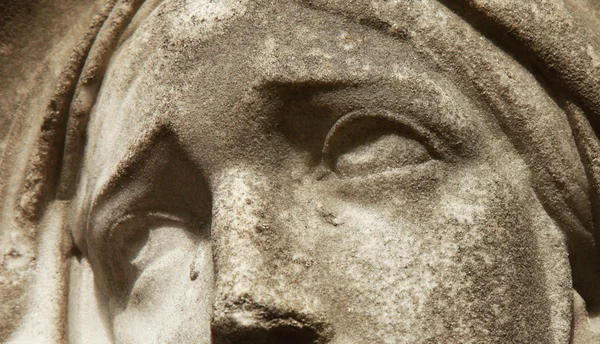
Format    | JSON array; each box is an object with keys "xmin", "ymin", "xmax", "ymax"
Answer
[{"xmin": 310, "ymin": 166, "xmax": 549, "ymax": 342}]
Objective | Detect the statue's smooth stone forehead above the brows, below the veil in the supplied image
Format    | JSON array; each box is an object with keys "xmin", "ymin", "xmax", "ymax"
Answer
[{"xmin": 82, "ymin": 1, "xmax": 464, "ymax": 181}]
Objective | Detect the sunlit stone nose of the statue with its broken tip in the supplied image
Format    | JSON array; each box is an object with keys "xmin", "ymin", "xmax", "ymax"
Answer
[{"xmin": 212, "ymin": 171, "xmax": 332, "ymax": 344}]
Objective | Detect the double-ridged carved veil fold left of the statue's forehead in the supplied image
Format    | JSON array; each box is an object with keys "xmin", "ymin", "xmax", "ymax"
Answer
[{"xmin": 16, "ymin": 0, "xmax": 148, "ymax": 223}]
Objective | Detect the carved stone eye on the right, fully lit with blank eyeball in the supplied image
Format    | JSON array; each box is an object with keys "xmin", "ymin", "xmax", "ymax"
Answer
[{"xmin": 323, "ymin": 111, "xmax": 435, "ymax": 177}]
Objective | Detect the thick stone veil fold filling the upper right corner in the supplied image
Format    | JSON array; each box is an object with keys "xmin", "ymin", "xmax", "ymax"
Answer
[{"xmin": 450, "ymin": 0, "xmax": 600, "ymax": 135}]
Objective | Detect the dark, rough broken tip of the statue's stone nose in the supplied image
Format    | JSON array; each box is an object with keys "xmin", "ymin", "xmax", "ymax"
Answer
[{"xmin": 212, "ymin": 298, "xmax": 333, "ymax": 344}]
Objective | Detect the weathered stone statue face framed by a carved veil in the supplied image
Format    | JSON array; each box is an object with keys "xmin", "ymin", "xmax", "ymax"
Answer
[{"xmin": 62, "ymin": 3, "xmax": 576, "ymax": 343}]
